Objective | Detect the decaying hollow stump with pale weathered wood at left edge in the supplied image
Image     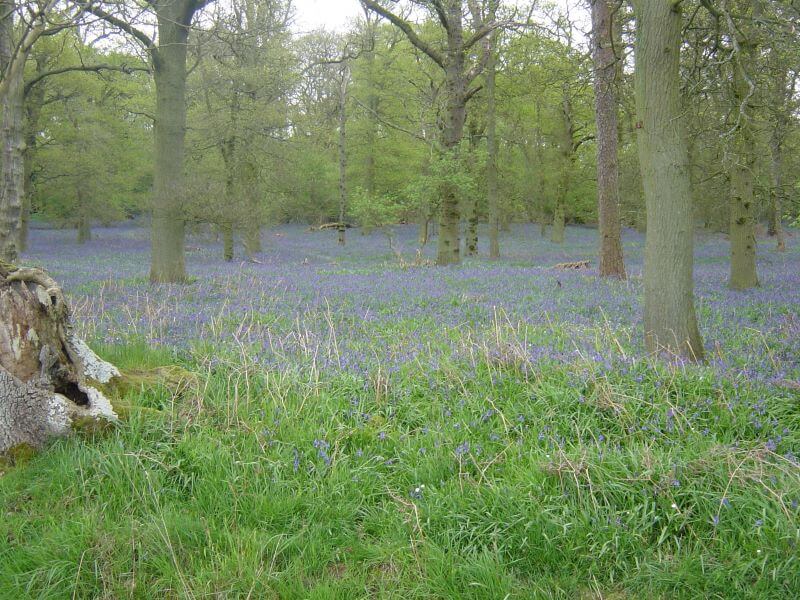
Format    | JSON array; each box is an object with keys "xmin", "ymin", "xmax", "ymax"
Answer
[{"xmin": 0, "ymin": 261, "xmax": 120, "ymax": 453}]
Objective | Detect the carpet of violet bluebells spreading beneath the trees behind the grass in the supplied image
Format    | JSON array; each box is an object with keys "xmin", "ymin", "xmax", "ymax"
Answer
[{"xmin": 21, "ymin": 226, "xmax": 800, "ymax": 381}]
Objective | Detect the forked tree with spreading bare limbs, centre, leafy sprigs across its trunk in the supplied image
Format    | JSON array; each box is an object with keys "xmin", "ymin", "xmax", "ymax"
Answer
[{"xmin": 361, "ymin": 0, "xmax": 499, "ymax": 266}]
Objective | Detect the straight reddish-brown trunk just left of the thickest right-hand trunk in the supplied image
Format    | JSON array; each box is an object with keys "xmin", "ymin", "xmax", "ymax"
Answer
[{"xmin": 590, "ymin": 0, "xmax": 626, "ymax": 279}]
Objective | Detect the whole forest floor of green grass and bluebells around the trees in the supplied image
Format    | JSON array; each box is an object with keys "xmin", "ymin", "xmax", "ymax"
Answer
[{"xmin": 0, "ymin": 226, "xmax": 800, "ymax": 599}]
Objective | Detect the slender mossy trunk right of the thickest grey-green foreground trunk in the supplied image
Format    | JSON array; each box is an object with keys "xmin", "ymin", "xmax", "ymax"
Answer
[{"xmin": 729, "ymin": 30, "xmax": 758, "ymax": 290}]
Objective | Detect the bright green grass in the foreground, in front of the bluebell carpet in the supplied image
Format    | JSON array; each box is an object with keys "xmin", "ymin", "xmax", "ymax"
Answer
[{"xmin": 0, "ymin": 344, "xmax": 800, "ymax": 600}]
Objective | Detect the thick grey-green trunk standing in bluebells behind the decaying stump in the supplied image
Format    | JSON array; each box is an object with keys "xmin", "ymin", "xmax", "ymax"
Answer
[{"xmin": 150, "ymin": 0, "xmax": 196, "ymax": 283}]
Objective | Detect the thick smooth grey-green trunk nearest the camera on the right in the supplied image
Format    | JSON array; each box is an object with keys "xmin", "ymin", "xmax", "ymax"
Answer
[{"xmin": 634, "ymin": 0, "xmax": 703, "ymax": 360}]
